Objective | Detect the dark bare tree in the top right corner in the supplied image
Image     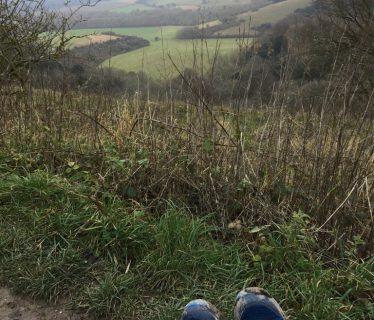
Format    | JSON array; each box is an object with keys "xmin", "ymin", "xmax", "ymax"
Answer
[{"xmin": 316, "ymin": 0, "xmax": 374, "ymax": 100}]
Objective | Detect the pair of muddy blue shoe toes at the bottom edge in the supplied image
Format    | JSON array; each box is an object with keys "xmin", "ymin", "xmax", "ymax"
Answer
[{"xmin": 182, "ymin": 288, "xmax": 286, "ymax": 320}]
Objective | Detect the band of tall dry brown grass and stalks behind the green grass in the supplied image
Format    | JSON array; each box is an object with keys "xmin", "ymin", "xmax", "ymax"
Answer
[{"xmin": 1, "ymin": 79, "xmax": 374, "ymax": 251}]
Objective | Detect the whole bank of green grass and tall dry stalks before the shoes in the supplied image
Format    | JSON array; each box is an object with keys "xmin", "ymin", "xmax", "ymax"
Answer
[{"xmin": 0, "ymin": 83, "xmax": 374, "ymax": 319}]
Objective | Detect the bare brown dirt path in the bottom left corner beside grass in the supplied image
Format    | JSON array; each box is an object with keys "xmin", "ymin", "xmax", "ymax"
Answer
[{"xmin": 0, "ymin": 288, "xmax": 88, "ymax": 320}]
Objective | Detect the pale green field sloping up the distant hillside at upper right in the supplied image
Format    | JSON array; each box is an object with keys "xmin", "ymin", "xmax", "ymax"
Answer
[{"xmin": 220, "ymin": 0, "xmax": 312, "ymax": 35}]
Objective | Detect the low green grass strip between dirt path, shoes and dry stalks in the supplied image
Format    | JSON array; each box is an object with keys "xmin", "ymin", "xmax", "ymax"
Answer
[{"xmin": 0, "ymin": 164, "xmax": 374, "ymax": 319}]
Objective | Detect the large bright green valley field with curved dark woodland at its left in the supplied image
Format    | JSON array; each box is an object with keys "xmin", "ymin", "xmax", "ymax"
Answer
[{"xmin": 72, "ymin": 26, "xmax": 237, "ymax": 78}]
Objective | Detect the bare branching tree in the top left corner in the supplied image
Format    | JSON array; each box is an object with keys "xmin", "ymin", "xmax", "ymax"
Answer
[{"xmin": 0, "ymin": 0, "xmax": 98, "ymax": 84}]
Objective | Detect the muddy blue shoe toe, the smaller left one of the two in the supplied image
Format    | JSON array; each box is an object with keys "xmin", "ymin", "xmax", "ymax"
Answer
[{"xmin": 182, "ymin": 299, "xmax": 219, "ymax": 320}]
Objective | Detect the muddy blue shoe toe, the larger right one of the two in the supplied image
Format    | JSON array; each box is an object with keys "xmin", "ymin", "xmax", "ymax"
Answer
[{"xmin": 234, "ymin": 288, "xmax": 286, "ymax": 320}]
